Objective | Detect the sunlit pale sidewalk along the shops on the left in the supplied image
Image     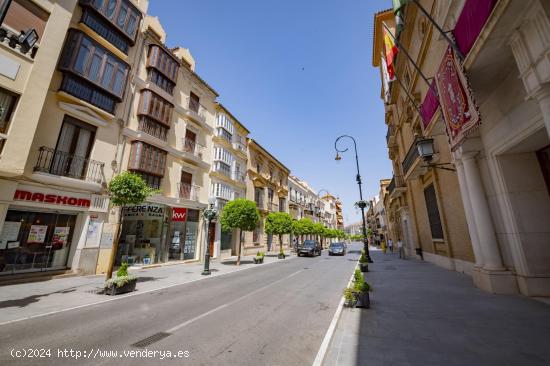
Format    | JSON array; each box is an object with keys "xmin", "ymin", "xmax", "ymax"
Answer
[{"xmin": 0, "ymin": 254, "xmax": 296, "ymax": 325}]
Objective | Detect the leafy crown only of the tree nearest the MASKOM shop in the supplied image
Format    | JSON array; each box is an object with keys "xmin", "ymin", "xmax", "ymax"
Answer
[{"xmin": 109, "ymin": 172, "xmax": 156, "ymax": 206}]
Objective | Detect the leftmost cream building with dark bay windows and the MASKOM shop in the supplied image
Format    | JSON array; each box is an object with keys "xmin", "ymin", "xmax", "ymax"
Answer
[{"xmin": 0, "ymin": 0, "xmax": 148, "ymax": 276}]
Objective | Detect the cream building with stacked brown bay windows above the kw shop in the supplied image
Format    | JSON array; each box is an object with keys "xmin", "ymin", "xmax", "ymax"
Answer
[{"xmin": 116, "ymin": 16, "xmax": 219, "ymax": 265}]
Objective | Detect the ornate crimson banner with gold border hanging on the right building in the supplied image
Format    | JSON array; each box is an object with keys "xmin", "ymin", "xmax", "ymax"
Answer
[{"xmin": 435, "ymin": 46, "xmax": 481, "ymax": 151}]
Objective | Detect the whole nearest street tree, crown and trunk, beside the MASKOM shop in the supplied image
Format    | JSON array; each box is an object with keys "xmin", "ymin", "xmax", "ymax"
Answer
[{"xmin": 106, "ymin": 172, "xmax": 156, "ymax": 280}]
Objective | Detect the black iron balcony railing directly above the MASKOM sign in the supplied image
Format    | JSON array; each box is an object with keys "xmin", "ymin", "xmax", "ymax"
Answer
[{"xmin": 34, "ymin": 146, "xmax": 105, "ymax": 184}]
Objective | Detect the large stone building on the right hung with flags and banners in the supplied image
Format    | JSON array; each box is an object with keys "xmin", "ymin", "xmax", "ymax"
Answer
[{"xmin": 373, "ymin": 0, "xmax": 550, "ymax": 296}]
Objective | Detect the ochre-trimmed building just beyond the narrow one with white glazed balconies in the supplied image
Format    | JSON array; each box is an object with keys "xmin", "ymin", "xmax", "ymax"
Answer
[{"xmin": 244, "ymin": 138, "xmax": 290, "ymax": 254}]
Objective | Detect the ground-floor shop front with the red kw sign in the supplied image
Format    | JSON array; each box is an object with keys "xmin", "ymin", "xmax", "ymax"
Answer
[{"xmin": 116, "ymin": 203, "xmax": 199, "ymax": 265}]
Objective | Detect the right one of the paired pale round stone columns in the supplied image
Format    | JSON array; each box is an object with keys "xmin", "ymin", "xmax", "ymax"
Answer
[{"xmin": 462, "ymin": 153, "xmax": 504, "ymax": 271}]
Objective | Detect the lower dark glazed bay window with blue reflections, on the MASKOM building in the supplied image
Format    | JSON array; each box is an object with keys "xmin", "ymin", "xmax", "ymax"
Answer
[{"xmin": 59, "ymin": 29, "xmax": 129, "ymax": 106}]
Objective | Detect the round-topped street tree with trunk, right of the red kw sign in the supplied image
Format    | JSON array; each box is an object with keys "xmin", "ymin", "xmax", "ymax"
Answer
[{"xmin": 220, "ymin": 198, "xmax": 260, "ymax": 266}]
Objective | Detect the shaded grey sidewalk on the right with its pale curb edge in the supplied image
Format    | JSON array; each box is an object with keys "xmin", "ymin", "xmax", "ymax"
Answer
[{"xmin": 324, "ymin": 251, "xmax": 550, "ymax": 366}]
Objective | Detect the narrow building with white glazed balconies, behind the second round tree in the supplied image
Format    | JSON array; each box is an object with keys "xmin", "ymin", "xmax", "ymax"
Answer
[{"xmin": 210, "ymin": 104, "xmax": 249, "ymax": 257}]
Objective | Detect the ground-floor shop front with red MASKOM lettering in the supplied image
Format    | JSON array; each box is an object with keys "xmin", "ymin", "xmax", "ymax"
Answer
[{"xmin": 0, "ymin": 184, "xmax": 109, "ymax": 276}]
